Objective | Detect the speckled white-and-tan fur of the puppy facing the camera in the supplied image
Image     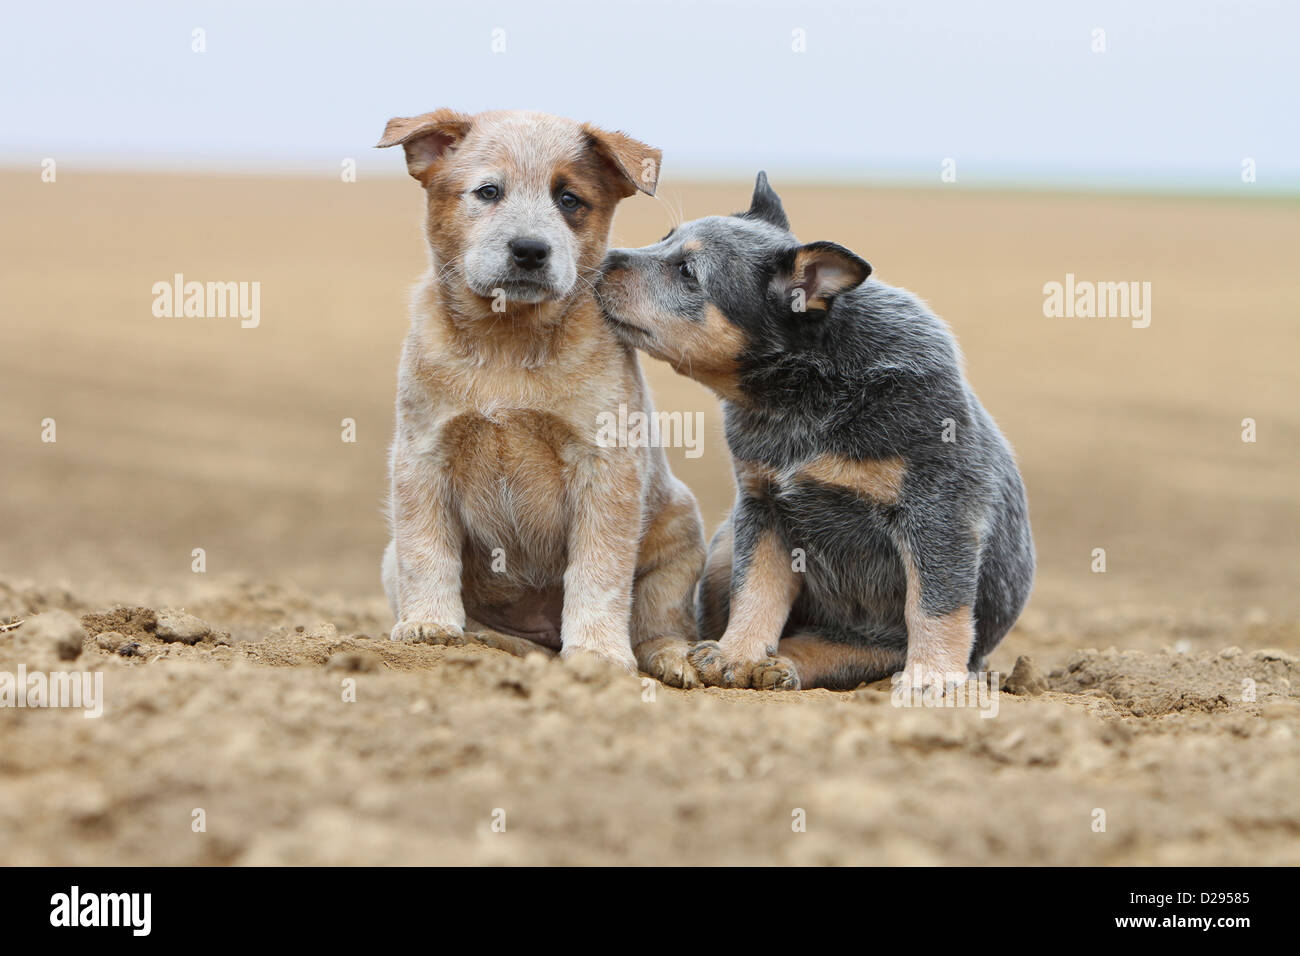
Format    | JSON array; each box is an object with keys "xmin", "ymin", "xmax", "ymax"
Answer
[{"xmin": 380, "ymin": 109, "xmax": 705, "ymax": 685}]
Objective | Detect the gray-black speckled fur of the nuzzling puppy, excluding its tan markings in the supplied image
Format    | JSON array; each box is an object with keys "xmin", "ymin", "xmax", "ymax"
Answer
[{"xmin": 607, "ymin": 174, "xmax": 1035, "ymax": 669}]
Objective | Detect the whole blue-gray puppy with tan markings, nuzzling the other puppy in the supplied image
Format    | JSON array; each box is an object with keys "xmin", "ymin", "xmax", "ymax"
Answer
[{"xmin": 597, "ymin": 173, "xmax": 1034, "ymax": 689}]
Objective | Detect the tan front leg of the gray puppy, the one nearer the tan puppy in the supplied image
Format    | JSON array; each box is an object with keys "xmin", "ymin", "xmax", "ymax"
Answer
[{"xmin": 719, "ymin": 531, "xmax": 802, "ymax": 661}]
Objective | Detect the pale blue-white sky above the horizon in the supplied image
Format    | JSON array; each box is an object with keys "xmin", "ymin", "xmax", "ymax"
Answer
[{"xmin": 0, "ymin": 0, "xmax": 1300, "ymax": 191}]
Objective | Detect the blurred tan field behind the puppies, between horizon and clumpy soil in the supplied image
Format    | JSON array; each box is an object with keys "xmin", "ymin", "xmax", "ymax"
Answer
[{"xmin": 0, "ymin": 169, "xmax": 1300, "ymax": 610}]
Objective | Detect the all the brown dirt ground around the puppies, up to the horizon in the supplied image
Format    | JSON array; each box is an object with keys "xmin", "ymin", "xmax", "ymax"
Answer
[{"xmin": 0, "ymin": 174, "xmax": 1300, "ymax": 864}]
